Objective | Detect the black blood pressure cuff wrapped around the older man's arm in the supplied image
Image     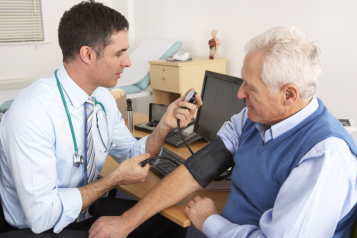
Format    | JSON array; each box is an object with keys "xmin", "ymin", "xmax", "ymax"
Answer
[{"xmin": 184, "ymin": 137, "xmax": 233, "ymax": 188}]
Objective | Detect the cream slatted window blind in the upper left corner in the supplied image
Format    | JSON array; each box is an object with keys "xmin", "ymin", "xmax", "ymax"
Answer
[{"xmin": 0, "ymin": 0, "xmax": 44, "ymax": 43}]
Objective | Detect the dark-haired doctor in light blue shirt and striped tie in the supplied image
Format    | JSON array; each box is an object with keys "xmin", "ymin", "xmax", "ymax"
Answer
[{"xmin": 0, "ymin": 1, "xmax": 202, "ymax": 237}]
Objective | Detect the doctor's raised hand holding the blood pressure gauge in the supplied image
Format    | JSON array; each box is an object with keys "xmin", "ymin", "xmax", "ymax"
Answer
[{"xmin": 161, "ymin": 88, "xmax": 202, "ymax": 129}]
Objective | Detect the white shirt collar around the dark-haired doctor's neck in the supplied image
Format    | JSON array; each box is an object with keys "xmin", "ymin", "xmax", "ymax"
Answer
[{"xmin": 57, "ymin": 65, "xmax": 89, "ymax": 108}]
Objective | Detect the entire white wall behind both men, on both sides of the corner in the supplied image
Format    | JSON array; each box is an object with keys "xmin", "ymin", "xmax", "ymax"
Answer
[{"xmin": 0, "ymin": 0, "xmax": 357, "ymax": 141}]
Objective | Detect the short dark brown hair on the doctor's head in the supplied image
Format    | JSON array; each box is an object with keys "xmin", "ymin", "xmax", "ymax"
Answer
[{"xmin": 58, "ymin": 0, "xmax": 129, "ymax": 63}]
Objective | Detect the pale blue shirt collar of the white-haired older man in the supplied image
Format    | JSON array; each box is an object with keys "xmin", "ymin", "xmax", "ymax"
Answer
[{"xmin": 256, "ymin": 96, "xmax": 319, "ymax": 143}]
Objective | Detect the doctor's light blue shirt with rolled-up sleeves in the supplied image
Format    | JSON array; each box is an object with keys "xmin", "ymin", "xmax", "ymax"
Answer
[{"xmin": 0, "ymin": 66, "xmax": 147, "ymax": 233}]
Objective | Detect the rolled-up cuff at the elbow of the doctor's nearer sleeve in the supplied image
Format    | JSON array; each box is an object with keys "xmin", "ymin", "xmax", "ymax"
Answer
[{"xmin": 53, "ymin": 188, "xmax": 82, "ymax": 234}]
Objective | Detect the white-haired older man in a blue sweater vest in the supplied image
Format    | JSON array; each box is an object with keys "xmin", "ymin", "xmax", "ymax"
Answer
[{"xmin": 90, "ymin": 27, "xmax": 357, "ymax": 238}]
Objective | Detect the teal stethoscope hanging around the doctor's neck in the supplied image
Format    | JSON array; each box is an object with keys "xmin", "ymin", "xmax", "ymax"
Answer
[{"xmin": 55, "ymin": 69, "xmax": 115, "ymax": 168}]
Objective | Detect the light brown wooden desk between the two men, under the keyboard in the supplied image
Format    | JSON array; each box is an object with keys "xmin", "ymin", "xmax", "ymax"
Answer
[{"xmin": 100, "ymin": 112, "xmax": 229, "ymax": 227}]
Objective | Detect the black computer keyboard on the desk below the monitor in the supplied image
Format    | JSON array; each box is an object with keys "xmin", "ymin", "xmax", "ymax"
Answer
[{"xmin": 150, "ymin": 147, "xmax": 185, "ymax": 178}]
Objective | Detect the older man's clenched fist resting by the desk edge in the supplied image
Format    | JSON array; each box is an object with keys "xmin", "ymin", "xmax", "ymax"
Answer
[{"xmin": 185, "ymin": 196, "xmax": 219, "ymax": 232}]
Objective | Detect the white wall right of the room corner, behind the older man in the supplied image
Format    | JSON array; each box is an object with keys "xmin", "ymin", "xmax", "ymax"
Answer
[{"xmin": 119, "ymin": 0, "xmax": 357, "ymax": 141}]
